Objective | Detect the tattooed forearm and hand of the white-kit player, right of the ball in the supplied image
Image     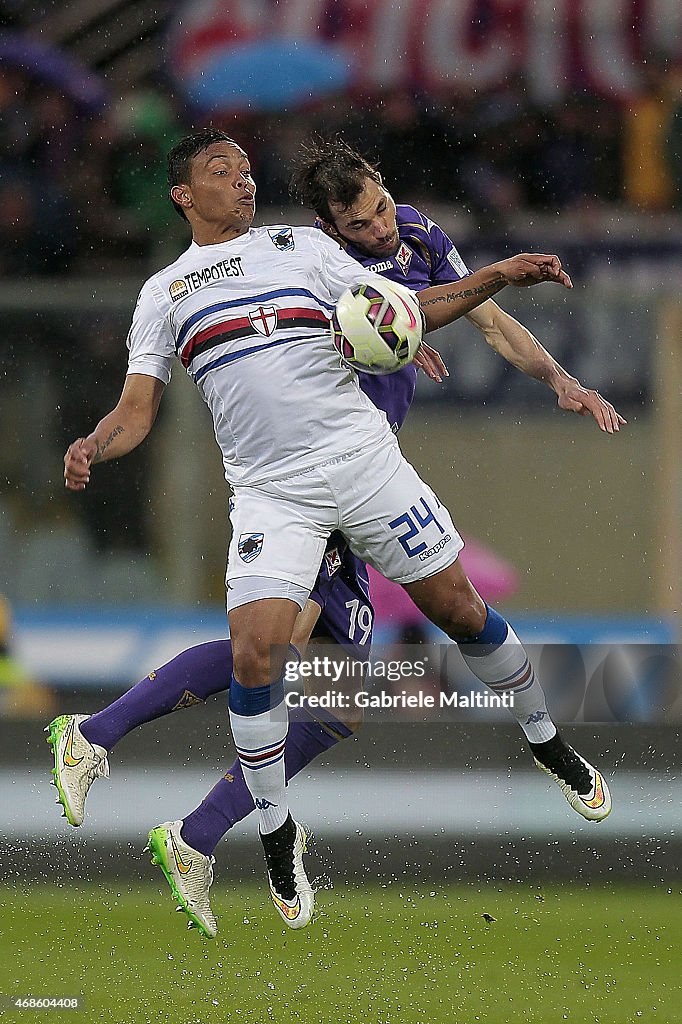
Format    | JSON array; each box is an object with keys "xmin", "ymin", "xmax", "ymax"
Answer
[{"xmin": 419, "ymin": 253, "xmax": 573, "ymax": 332}]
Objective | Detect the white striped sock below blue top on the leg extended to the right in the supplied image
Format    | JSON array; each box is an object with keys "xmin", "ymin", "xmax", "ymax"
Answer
[{"xmin": 459, "ymin": 624, "xmax": 556, "ymax": 743}]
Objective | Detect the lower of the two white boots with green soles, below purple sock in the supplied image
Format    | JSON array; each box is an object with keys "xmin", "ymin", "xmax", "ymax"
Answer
[{"xmin": 144, "ymin": 821, "xmax": 218, "ymax": 939}]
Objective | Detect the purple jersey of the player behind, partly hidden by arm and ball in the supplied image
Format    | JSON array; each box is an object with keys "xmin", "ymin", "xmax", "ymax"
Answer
[{"xmin": 346, "ymin": 206, "xmax": 470, "ymax": 433}]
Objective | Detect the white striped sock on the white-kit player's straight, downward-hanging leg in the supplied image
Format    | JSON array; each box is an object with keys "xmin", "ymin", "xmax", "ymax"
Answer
[{"xmin": 229, "ymin": 701, "xmax": 289, "ymax": 835}]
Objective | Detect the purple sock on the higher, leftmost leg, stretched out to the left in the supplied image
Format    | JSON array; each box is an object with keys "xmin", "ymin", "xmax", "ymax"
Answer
[{"xmin": 81, "ymin": 640, "xmax": 232, "ymax": 751}]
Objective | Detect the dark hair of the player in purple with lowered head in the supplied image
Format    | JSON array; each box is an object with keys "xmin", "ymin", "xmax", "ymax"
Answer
[{"xmin": 289, "ymin": 135, "xmax": 382, "ymax": 224}]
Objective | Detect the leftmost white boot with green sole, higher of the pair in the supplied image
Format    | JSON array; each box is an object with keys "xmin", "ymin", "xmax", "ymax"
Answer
[{"xmin": 45, "ymin": 715, "xmax": 109, "ymax": 825}]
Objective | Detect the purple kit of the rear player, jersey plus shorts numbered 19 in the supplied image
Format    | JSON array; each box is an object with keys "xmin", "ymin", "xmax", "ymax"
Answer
[{"xmin": 312, "ymin": 206, "xmax": 469, "ymax": 660}]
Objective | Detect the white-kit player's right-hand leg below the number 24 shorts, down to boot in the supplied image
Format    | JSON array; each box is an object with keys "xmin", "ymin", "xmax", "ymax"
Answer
[{"xmin": 406, "ymin": 561, "xmax": 611, "ymax": 821}]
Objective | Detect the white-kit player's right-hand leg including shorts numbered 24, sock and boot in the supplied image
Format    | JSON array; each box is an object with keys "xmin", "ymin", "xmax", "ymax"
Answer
[{"xmin": 336, "ymin": 445, "xmax": 611, "ymax": 821}]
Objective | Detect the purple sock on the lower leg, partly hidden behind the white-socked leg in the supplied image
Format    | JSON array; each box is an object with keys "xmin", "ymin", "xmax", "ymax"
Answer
[{"xmin": 181, "ymin": 708, "xmax": 352, "ymax": 857}]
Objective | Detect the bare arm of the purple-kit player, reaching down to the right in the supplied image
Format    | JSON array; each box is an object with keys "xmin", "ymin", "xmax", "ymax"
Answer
[{"xmin": 467, "ymin": 301, "xmax": 626, "ymax": 434}]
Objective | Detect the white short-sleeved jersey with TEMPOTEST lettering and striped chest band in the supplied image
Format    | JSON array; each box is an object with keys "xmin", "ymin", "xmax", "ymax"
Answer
[{"xmin": 128, "ymin": 226, "xmax": 399, "ymax": 484}]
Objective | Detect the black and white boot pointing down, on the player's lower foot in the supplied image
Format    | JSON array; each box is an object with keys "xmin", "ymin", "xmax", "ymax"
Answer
[{"xmin": 260, "ymin": 814, "xmax": 315, "ymax": 928}]
